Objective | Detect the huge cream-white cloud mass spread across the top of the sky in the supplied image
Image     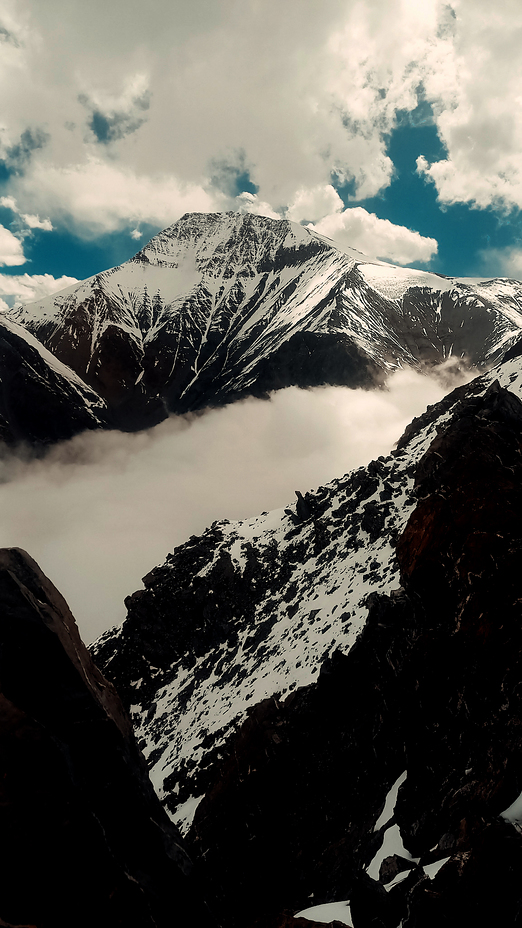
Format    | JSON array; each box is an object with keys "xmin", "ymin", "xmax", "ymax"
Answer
[{"xmin": 0, "ymin": 0, "xmax": 522, "ymax": 233}]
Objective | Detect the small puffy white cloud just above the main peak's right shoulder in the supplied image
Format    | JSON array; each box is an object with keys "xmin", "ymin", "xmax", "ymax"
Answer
[{"xmin": 311, "ymin": 206, "xmax": 437, "ymax": 264}]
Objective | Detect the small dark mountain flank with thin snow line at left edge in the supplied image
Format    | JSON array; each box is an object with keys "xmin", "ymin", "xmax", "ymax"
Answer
[{"xmin": 0, "ymin": 313, "xmax": 109, "ymax": 446}]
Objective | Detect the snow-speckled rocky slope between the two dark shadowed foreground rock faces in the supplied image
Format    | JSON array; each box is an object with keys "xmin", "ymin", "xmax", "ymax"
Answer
[{"xmin": 94, "ymin": 344, "xmax": 522, "ymax": 828}]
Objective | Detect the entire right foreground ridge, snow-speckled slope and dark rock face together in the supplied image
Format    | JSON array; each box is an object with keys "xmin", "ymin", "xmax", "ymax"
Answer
[{"xmin": 93, "ymin": 346, "xmax": 522, "ymax": 928}]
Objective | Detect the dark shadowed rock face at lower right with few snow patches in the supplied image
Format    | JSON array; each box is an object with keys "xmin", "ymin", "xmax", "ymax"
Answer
[{"xmin": 168, "ymin": 385, "xmax": 522, "ymax": 928}]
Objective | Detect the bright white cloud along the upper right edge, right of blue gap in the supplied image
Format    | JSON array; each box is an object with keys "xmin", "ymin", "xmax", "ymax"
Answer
[{"xmin": 417, "ymin": 0, "xmax": 522, "ymax": 208}]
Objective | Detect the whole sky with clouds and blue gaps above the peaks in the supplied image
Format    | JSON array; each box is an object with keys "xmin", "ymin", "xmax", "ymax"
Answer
[{"xmin": 0, "ymin": 0, "xmax": 522, "ymax": 305}]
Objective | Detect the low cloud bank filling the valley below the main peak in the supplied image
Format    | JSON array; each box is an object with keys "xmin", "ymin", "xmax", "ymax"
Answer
[{"xmin": 0, "ymin": 368, "xmax": 465, "ymax": 641}]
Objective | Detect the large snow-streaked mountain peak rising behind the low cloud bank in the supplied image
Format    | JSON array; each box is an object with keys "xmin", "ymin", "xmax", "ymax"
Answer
[{"xmin": 9, "ymin": 213, "xmax": 522, "ymax": 429}]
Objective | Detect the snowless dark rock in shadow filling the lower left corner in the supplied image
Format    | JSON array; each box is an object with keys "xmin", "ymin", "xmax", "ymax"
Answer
[{"xmin": 0, "ymin": 548, "xmax": 213, "ymax": 928}]
